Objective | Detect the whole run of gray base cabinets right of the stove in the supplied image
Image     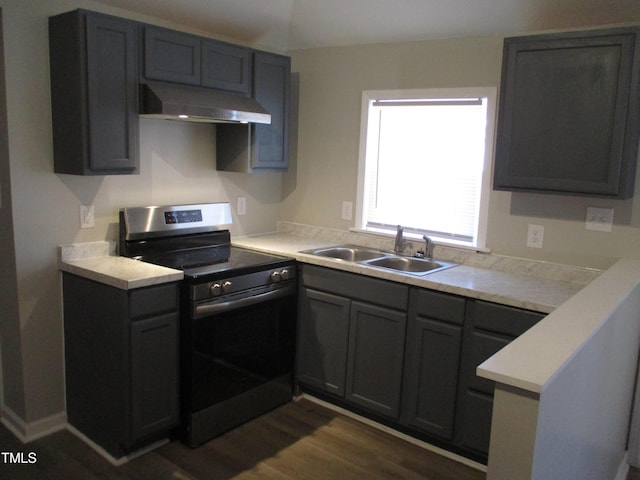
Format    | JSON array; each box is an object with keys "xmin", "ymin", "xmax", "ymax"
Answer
[{"xmin": 296, "ymin": 264, "xmax": 544, "ymax": 462}]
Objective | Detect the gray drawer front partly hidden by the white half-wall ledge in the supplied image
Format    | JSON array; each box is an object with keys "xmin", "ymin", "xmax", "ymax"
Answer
[{"xmin": 473, "ymin": 301, "xmax": 545, "ymax": 338}]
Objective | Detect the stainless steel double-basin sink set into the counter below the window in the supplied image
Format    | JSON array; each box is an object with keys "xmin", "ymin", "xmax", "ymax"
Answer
[{"xmin": 301, "ymin": 245, "xmax": 457, "ymax": 275}]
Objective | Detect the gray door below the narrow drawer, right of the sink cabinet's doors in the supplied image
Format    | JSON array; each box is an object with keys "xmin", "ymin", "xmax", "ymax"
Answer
[{"xmin": 403, "ymin": 316, "xmax": 462, "ymax": 440}]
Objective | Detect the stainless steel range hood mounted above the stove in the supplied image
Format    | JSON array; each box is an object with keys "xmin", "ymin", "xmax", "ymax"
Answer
[{"xmin": 140, "ymin": 82, "xmax": 271, "ymax": 123}]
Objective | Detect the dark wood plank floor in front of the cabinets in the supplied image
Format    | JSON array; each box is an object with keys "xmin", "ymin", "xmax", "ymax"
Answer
[{"xmin": 0, "ymin": 399, "xmax": 485, "ymax": 480}]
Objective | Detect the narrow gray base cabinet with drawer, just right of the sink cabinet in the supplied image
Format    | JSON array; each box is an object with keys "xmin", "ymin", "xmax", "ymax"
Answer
[{"xmin": 401, "ymin": 288, "xmax": 466, "ymax": 440}]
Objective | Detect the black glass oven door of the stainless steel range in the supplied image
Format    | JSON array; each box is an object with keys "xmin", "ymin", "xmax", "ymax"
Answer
[{"xmin": 182, "ymin": 282, "xmax": 296, "ymax": 446}]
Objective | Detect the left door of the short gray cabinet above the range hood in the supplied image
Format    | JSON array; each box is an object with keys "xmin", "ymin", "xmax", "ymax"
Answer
[{"xmin": 144, "ymin": 26, "xmax": 201, "ymax": 85}]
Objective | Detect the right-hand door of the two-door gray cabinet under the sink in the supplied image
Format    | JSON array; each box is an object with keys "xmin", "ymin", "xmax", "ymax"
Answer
[{"xmin": 346, "ymin": 302, "xmax": 407, "ymax": 419}]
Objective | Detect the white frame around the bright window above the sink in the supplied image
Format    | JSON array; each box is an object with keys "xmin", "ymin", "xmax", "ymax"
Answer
[{"xmin": 353, "ymin": 87, "xmax": 497, "ymax": 251}]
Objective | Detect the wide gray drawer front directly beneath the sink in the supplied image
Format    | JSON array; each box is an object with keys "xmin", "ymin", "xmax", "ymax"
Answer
[{"xmin": 302, "ymin": 265, "xmax": 409, "ymax": 311}]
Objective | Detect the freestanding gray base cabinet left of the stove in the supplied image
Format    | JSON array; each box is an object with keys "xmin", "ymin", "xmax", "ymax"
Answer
[{"xmin": 63, "ymin": 273, "xmax": 179, "ymax": 458}]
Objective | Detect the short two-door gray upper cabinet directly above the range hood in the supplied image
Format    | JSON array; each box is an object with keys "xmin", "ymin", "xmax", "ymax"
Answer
[{"xmin": 142, "ymin": 26, "xmax": 253, "ymax": 95}]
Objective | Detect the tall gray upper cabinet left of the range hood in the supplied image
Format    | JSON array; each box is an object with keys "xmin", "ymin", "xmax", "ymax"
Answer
[{"xmin": 49, "ymin": 10, "xmax": 139, "ymax": 175}]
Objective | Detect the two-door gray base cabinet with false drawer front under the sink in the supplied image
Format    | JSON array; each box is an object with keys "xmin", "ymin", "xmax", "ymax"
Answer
[{"xmin": 297, "ymin": 265, "xmax": 408, "ymax": 419}]
